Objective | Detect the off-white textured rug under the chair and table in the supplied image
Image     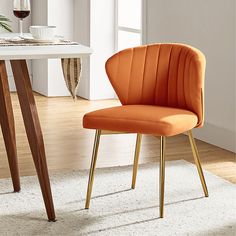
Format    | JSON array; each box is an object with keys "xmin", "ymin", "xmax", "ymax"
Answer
[{"xmin": 0, "ymin": 160, "xmax": 236, "ymax": 236}]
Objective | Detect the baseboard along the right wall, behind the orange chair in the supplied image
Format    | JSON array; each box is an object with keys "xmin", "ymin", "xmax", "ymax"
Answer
[{"xmin": 193, "ymin": 122, "xmax": 236, "ymax": 153}]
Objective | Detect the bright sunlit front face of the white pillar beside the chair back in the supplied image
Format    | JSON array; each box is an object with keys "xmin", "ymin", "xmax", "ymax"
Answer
[{"xmin": 89, "ymin": 0, "xmax": 115, "ymax": 100}]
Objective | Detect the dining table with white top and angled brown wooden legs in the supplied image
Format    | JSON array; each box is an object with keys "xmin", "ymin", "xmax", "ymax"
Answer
[{"xmin": 0, "ymin": 34, "xmax": 92, "ymax": 221}]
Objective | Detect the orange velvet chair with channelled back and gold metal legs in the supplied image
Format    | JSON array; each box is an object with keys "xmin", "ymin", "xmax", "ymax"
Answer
[{"xmin": 83, "ymin": 44, "xmax": 208, "ymax": 218}]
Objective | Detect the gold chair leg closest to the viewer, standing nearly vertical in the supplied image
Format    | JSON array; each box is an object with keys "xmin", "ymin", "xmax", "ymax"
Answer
[{"xmin": 159, "ymin": 136, "xmax": 166, "ymax": 218}]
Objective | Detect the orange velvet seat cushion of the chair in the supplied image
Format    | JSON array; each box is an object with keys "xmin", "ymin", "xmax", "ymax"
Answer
[{"xmin": 83, "ymin": 105, "xmax": 198, "ymax": 136}]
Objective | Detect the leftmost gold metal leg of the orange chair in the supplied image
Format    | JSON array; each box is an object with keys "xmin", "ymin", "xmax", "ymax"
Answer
[{"xmin": 85, "ymin": 130, "xmax": 101, "ymax": 209}]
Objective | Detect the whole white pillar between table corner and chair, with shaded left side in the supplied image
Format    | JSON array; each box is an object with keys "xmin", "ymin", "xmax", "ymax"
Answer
[{"xmin": 74, "ymin": 0, "xmax": 115, "ymax": 100}]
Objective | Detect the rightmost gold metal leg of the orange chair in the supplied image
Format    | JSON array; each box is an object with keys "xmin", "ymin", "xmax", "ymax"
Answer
[{"xmin": 188, "ymin": 130, "xmax": 209, "ymax": 197}]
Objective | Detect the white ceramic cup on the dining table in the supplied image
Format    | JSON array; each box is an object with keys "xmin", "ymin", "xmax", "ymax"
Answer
[{"xmin": 30, "ymin": 25, "xmax": 56, "ymax": 40}]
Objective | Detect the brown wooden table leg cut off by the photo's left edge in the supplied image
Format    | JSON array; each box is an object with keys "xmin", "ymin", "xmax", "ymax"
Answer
[{"xmin": 0, "ymin": 60, "xmax": 20, "ymax": 192}]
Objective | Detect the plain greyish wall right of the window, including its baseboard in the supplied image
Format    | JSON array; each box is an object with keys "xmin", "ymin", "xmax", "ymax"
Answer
[{"xmin": 146, "ymin": 0, "xmax": 236, "ymax": 152}]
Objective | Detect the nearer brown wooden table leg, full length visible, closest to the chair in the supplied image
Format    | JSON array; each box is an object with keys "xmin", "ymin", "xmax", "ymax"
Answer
[{"xmin": 11, "ymin": 60, "xmax": 55, "ymax": 221}]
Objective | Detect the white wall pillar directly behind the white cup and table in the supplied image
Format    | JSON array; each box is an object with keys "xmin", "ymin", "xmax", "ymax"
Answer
[{"xmin": 32, "ymin": 0, "xmax": 74, "ymax": 97}]
